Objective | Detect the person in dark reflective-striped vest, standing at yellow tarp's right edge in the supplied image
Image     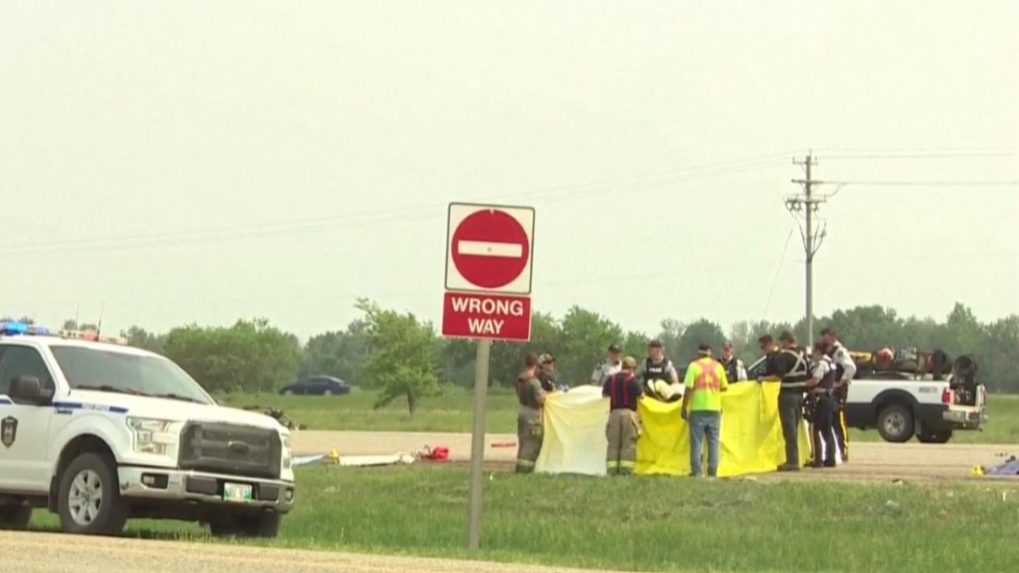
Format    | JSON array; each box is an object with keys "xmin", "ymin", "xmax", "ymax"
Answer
[{"xmin": 774, "ymin": 330, "xmax": 810, "ymax": 471}]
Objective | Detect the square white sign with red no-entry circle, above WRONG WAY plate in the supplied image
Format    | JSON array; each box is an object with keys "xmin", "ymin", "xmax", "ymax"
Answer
[{"xmin": 445, "ymin": 203, "xmax": 534, "ymax": 295}]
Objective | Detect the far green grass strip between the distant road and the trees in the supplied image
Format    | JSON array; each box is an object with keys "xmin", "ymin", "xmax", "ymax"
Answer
[{"xmin": 222, "ymin": 387, "xmax": 1019, "ymax": 444}]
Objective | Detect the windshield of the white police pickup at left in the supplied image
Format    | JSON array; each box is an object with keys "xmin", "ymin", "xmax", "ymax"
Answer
[{"xmin": 50, "ymin": 346, "xmax": 211, "ymax": 404}]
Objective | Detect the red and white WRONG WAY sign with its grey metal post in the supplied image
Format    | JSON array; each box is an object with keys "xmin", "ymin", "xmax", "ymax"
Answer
[{"xmin": 442, "ymin": 203, "xmax": 534, "ymax": 551}]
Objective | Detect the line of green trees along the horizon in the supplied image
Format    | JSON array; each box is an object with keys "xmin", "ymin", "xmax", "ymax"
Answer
[{"xmin": 41, "ymin": 300, "xmax": 1019, "ymax": 412}]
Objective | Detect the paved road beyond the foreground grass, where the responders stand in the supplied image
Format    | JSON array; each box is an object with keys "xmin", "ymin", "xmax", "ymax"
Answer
[{"xmin": 293, "ymin": 431, "xmax": 1019, "ymax": 480}]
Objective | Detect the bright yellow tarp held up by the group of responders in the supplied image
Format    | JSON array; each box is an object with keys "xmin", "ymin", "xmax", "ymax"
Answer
[{"xmin": 636, "ymin": 382, "xmax": 810, "ymax": 477}]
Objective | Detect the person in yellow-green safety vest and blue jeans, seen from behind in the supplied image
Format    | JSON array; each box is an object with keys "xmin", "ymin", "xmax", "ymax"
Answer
[{"xmin": 682, "ymin": 345, "xmax": 729, "ymax": 478}]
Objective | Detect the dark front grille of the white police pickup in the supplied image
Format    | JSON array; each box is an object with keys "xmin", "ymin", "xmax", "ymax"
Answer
[{"xmin": 179, "ymin": 422, "xmax": 281, "ymax": 479}]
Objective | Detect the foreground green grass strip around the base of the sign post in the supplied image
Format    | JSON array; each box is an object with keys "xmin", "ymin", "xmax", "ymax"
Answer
[{"xmin": 29, "ymin": 466, "xmax": 1019, "ymax": 573}]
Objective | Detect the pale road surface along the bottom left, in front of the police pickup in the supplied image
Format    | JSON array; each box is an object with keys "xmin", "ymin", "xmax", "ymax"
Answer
[{"xmin": 0, "ymin": 531, "xmax": 619, "ymax": 573}]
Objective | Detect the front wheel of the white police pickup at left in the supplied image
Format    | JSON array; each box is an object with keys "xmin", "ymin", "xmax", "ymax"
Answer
[{"xmin": 57, "ymin": 452, "xmax": 127, "ymax": 535}]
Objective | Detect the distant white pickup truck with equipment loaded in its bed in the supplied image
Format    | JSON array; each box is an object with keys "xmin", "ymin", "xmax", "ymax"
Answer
[{"xmin": 748, "ymin": 358, "xmax": 987, "ymax": 444}]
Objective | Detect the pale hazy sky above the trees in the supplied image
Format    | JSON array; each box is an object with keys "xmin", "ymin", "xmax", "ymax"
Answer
[{"xmin": 0, "ymin": 0, "xmax": 1019, "ymax": 336}]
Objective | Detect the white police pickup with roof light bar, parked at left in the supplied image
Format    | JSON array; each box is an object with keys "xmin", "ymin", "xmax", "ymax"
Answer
[{"xmin": 0, "ymin": 324, "xmax": 294, "ymax": 537}]
